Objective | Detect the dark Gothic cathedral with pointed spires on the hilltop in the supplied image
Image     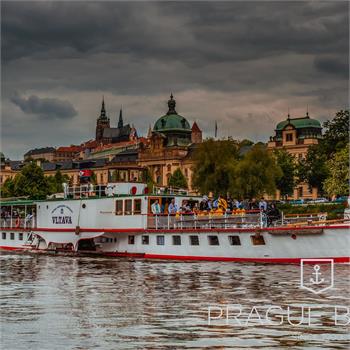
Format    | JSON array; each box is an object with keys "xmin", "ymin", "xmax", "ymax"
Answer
[{"xmin": 96, "ymin": 99, "xmax": 137, "ymax": 144}]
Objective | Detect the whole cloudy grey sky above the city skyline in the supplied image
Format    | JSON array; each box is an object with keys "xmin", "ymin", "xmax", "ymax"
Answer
[{"xmin": 1, "ymin": 1, "xmax": 349, "ymax": 159}]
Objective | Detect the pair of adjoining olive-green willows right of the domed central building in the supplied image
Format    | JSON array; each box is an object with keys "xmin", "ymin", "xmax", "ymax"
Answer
[{"xmin": 193, "ymin": 139, "xmax": 282, "ymax": 198}]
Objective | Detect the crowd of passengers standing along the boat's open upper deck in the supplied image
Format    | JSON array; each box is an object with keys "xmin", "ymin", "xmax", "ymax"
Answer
[{"xmin": 151, "ymin": 195, "xmax": 281, "ymax": 225}]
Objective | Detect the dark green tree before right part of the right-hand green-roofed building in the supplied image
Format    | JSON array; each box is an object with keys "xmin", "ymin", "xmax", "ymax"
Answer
[{"xmin": 297, "ymin": 145, "xmax": 329, "ymax": 194}]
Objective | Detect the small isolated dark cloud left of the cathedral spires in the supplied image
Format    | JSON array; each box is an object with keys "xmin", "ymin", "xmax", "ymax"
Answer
[{"xmin": 11, "ymin": 94, "xmax": 77, "ymax": 119}]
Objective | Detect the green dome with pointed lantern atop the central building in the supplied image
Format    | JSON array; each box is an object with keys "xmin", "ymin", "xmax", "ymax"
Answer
[{"xmin": 153, "ymin": 94, "xmax": 191, "ymax": 132}]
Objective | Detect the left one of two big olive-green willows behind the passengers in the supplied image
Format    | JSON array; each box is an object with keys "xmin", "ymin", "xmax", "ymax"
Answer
[{"xmin": 192, "ymin": 139, "xmax": 239, "ymax": 195}]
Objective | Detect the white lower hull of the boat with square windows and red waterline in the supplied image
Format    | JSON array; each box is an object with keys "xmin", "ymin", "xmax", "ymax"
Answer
[{"xmin": 0, "ymin": 225, "xmax": 350, "ymax": 263}]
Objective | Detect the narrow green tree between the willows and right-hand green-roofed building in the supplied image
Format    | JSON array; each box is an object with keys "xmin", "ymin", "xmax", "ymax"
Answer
[{"xmin": 274, "ymin": 149, "xmax": 296, "ymax": 196}]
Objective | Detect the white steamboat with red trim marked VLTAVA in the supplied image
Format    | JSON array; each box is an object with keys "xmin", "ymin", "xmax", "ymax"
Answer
[{"xmin": 0, "ymin": 182, "xmax": 350, "ymax": 263}]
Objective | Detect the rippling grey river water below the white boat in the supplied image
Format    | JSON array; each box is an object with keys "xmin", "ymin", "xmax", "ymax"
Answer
[{"xmin": 0, "ymin": 253, "xmax": 350, "ymax": 350}]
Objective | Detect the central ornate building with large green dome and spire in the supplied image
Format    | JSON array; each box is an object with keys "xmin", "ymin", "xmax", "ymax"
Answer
[{"xmin": 138, "ymin": 94, "xmax": 202, "ymax": 189}]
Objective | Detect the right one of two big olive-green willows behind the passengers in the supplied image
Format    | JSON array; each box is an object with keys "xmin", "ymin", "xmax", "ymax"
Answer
[{"xmin": 230, "ymin": 145, "xmax": 282, "ymax": 198}]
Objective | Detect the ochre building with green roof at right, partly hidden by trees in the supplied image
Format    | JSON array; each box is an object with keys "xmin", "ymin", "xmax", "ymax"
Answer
[{"xmin": 267, "ymin": 112, "xmax": 322, "ymax": 199}]
